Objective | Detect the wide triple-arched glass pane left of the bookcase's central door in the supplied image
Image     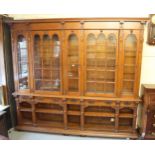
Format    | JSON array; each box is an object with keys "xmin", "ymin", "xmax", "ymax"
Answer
[{"xmin": 34, "ymin": 34, "xmax": 60, "ymax": 91}]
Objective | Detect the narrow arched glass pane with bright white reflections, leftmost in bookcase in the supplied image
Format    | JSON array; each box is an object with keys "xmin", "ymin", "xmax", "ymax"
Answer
[{"xmin": 17, "ymin": 35, "xmax": 28, "ymax": 90}]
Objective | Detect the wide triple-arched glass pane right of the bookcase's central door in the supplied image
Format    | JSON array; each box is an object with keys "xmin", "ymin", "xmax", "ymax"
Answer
[{"xmin": 86, "ymin": 33, "xmax": 116, "ymax": 94}]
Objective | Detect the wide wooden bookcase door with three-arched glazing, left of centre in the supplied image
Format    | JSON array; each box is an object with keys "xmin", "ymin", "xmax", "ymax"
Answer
[{"xmin": 31, "ymin": 31, "xmax": 62, "ymax": 94}]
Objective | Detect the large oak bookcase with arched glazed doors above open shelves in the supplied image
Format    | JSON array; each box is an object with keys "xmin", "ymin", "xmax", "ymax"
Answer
[{"xmin": 10, "ymin": 18, "xmax": 147, "ymax": 138}]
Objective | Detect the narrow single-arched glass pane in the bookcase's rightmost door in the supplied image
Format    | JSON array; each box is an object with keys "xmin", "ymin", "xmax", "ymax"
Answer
[{"xmin": 123, "ymin": 34, "xmax": 137, "ymax": 93}]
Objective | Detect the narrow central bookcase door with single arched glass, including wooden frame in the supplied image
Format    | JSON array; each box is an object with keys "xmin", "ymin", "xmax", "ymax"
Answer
[{"xmin": 64, "ymin": 30, "xmax": 83, "ymax": 95}]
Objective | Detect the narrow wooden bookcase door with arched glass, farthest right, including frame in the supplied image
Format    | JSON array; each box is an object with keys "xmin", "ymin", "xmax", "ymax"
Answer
[{"xmin": 120, "ymin": 30, "xmax": 141, "ymax": 96}]
